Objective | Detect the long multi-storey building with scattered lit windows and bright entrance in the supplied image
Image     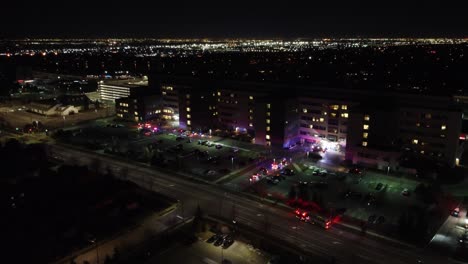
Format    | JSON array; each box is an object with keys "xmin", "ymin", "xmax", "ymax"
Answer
[{"xmin": 154, "ymin": 75, "xmax": 462, "ymax": 170}]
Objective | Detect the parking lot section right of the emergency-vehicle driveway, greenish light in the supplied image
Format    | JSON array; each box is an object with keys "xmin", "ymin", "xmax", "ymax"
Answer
[{"xmin": 236, "ymin": 159, "xmax": 439, "ymax": 239}]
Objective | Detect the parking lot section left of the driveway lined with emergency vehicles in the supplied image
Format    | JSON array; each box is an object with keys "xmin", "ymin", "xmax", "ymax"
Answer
[{"xmin": 55, "ymin": 124, "xmax": 262, "ymax": 182}]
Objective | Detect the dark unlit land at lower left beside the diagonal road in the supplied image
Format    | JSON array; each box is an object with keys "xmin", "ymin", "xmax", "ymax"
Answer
[{"xmin": 0, "ymin": 140, "xmax": 174, "ymax": 263}]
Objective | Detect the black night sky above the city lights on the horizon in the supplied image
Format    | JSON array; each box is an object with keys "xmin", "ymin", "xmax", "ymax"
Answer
[{"xmin": 0, "ymin": 0, "xmax": 468, "ymax": 38}]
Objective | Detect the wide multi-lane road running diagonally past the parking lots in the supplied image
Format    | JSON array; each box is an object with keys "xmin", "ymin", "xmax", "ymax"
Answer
[{"xmin": 51, "ymin": 145, "xmax": 454, "ymax": 264}]
